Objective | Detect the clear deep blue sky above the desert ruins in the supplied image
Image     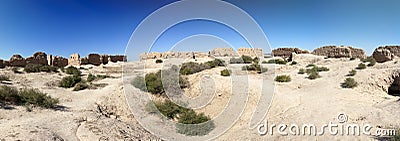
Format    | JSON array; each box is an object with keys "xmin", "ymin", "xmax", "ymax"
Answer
[{"xmin": 0, "ymin": 0, "xmax": 400, "ymax": 60}]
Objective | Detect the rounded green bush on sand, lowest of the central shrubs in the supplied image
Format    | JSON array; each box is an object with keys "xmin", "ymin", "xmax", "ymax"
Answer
[{"xmin": 176, "ymin": 110, "xmax": 215, "ymax": 136}]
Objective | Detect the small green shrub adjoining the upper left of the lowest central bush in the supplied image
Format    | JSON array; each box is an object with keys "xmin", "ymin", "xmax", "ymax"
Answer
[{"xmin": 154, "ymin": 100, "xmax": 189, "ymax": 119}]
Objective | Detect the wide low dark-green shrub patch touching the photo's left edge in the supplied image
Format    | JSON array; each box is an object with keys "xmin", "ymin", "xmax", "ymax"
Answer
[{"xmin": 0, "ymin": 86, "xmax": 59, "ymax": 108}]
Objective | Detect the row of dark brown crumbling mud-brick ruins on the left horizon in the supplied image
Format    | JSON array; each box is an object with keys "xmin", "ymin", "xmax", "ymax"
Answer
[{"xmin": 0, "ymin": 52, "xmax": 127, "ymax": 67}]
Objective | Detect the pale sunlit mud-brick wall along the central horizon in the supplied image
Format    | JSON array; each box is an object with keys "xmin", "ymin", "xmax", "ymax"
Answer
[{"xmin": 140, "ymin": 48, "xmax": 264, "ymax": 60}]
